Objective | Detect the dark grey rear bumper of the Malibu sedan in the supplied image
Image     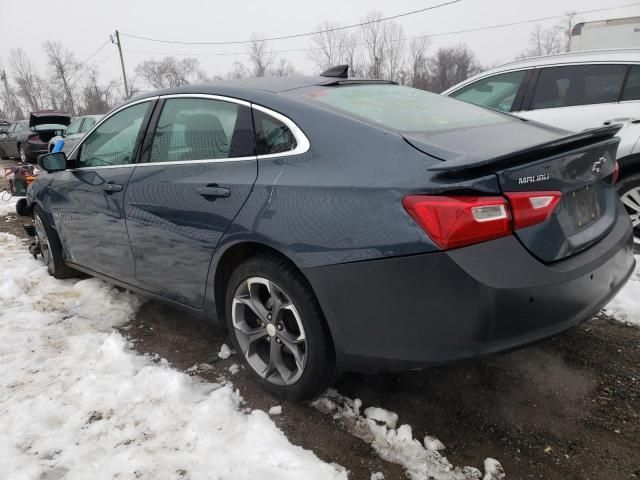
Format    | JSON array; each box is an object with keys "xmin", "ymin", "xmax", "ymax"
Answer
[{"xmin": 304, "ymin": 206, "xmax": 635, "ymax": 371}]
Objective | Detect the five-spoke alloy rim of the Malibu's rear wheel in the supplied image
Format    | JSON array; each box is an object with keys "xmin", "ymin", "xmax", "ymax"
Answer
[{"xmin": 231, "ymin": 277, "xmax": 307, "ymax": 386}]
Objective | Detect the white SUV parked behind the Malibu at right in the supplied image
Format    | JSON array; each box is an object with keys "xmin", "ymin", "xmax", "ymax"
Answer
[{"xmin": 443, "ymin": 49, "xmax": 640, "ymax": 244}]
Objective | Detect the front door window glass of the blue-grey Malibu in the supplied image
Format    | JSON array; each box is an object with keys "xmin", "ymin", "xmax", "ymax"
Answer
[{"xmin": 77, "ymin": 102, "xmax": 149, "ymax": 168}]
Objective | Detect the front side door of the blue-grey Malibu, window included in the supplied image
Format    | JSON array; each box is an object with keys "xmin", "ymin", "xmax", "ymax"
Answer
[{"xmin": 50, "ymin": 101, "xmax": 153, "ymax": 282}]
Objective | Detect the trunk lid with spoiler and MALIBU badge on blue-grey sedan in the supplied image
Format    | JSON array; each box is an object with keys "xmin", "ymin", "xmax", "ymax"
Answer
[{"xmin": 406, "ymin": 123, "xmax": 619, "ymax": 262}]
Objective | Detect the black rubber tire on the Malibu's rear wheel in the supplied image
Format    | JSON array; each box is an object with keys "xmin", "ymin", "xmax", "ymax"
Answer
[{"xmin": 225, "ymin": 254, "xmax": 336, "ymax": 400}]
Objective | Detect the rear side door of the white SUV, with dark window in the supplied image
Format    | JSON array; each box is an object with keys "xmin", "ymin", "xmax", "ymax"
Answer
[{"xmin": 517, "ymin": 64, "xmax": 638, "ymax": 132}]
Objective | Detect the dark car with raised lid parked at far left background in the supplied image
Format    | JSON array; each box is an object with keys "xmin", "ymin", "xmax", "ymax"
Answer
[{"xmin": 0, "ymin": 110, "xmax": 71, "ymax": 163}]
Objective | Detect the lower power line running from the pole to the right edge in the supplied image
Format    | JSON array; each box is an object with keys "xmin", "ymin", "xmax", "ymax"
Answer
[{"xmin": 120, "ymin": 2, "xmax": 640, "ymax": 57}]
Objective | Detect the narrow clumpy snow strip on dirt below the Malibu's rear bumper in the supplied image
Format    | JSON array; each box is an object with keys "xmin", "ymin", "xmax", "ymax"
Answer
[{"xmin": 312, "ymin": 389, "xmax": 503, "ymax": 480}]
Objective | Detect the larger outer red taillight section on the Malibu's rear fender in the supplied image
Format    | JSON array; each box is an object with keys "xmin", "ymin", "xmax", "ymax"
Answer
[{"xmin": 402, "ymin": 195, "xmax": 512, "ymax": 249}]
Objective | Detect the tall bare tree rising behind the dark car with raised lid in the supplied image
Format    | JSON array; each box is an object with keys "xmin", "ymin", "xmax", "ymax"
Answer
[{"xmin": 43, "ymin": 42, "xmax": 81, "ymax": 115}]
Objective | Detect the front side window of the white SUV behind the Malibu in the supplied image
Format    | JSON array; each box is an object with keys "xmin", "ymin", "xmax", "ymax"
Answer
[{"xmin": 451, "ymin": 70, "xmax": 527, "ymax": 112}]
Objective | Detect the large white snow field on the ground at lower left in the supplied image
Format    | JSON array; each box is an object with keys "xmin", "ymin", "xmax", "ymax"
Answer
[{"xmin": 0, "ymin": 233, "xmax": 346, "ymax": 480}]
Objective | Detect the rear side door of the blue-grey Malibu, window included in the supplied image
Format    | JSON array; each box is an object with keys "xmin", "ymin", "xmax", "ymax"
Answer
[{"xmin": 125, "ymin": 95, "xmax": 258, "ymax": 307}]
